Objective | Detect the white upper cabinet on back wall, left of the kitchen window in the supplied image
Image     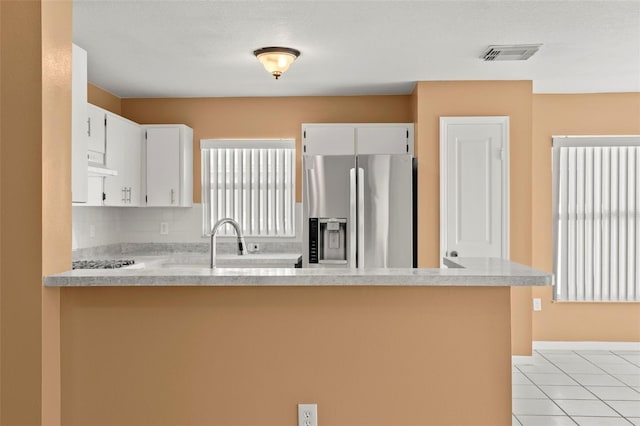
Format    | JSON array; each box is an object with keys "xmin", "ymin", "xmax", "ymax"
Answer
[{"xmin": 142, "ymin": 124, "xmax": 193, "ymax": 207}]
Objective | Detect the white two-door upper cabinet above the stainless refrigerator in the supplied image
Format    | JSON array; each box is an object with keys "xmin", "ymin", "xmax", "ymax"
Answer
[{"xmin": 302, "ymin": 123, "xmax": 414, "ymax": 155}]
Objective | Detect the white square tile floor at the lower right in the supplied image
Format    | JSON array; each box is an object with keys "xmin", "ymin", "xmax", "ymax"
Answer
[{"xmin": 512, "ymin": 350, "xmax": 640, "ymax": 426}]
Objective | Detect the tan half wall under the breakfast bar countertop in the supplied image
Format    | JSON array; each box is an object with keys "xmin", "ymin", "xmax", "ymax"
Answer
[{"xmin": 62, "ymin": 287, "xmax": 511, "ymax": 426}]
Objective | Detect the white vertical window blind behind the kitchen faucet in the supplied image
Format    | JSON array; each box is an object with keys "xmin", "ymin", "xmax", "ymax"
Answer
[{"xmin": 200, "ymin": 139, "xmax": 296, "ymax": 237}]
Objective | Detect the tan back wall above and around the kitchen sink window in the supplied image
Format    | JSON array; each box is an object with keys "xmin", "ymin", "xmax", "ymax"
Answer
[{"xmin": 122, "ymin": 96, "xmax": 411, "ymax": 202}]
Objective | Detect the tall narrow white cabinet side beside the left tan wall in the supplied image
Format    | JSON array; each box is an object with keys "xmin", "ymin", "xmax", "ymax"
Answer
[{"xmin": 71, "ymin": 44, "xmax": 88, "ymax": 203}]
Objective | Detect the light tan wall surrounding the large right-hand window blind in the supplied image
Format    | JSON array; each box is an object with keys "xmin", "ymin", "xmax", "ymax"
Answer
[{"xmin": 532, "ymin": 93, "xmax": 640, "ymax": 342}]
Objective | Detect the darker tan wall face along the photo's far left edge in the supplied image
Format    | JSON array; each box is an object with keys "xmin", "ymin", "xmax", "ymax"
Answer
[{"xmin": 0, "ymin": 1, "xmax": 42, "ymax": 425}]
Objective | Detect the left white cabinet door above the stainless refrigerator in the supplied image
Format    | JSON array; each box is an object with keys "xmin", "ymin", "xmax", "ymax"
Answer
[{"xmin": 302, "ymin": 124, "xmax": 355, "ymax": 155}]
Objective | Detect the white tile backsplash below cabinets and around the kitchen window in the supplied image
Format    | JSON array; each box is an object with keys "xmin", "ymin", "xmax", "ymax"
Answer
[{"xmin": 72, "ymin": 203, "xmax": 302, "ymax": 250}]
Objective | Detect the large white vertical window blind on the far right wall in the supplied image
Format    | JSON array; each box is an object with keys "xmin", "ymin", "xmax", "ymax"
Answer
[{"xmin": 553, "ymin": 136, "xmax": 640, "ymax": 301}]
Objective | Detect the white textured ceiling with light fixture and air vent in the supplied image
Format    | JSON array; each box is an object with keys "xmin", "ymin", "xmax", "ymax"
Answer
[{"xmin": 73, "ymin": 0, "xmax": 640, "ymax": 98}]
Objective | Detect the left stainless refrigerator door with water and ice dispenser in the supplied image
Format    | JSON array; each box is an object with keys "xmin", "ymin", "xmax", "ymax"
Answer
[{"xmin": 302, "ymin": 155, "xmax": 356, "ymax": 267}]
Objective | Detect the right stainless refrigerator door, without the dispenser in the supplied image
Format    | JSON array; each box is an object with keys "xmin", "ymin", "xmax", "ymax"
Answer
[{"xmin": 357, "ymin": 154, "xmax": 413, "ymax": 268}]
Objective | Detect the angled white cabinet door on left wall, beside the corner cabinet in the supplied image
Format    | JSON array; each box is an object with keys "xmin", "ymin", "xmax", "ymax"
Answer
[{"xmin": 104, "ymin": 112, "xmax": 142, "ymax": 207}]
